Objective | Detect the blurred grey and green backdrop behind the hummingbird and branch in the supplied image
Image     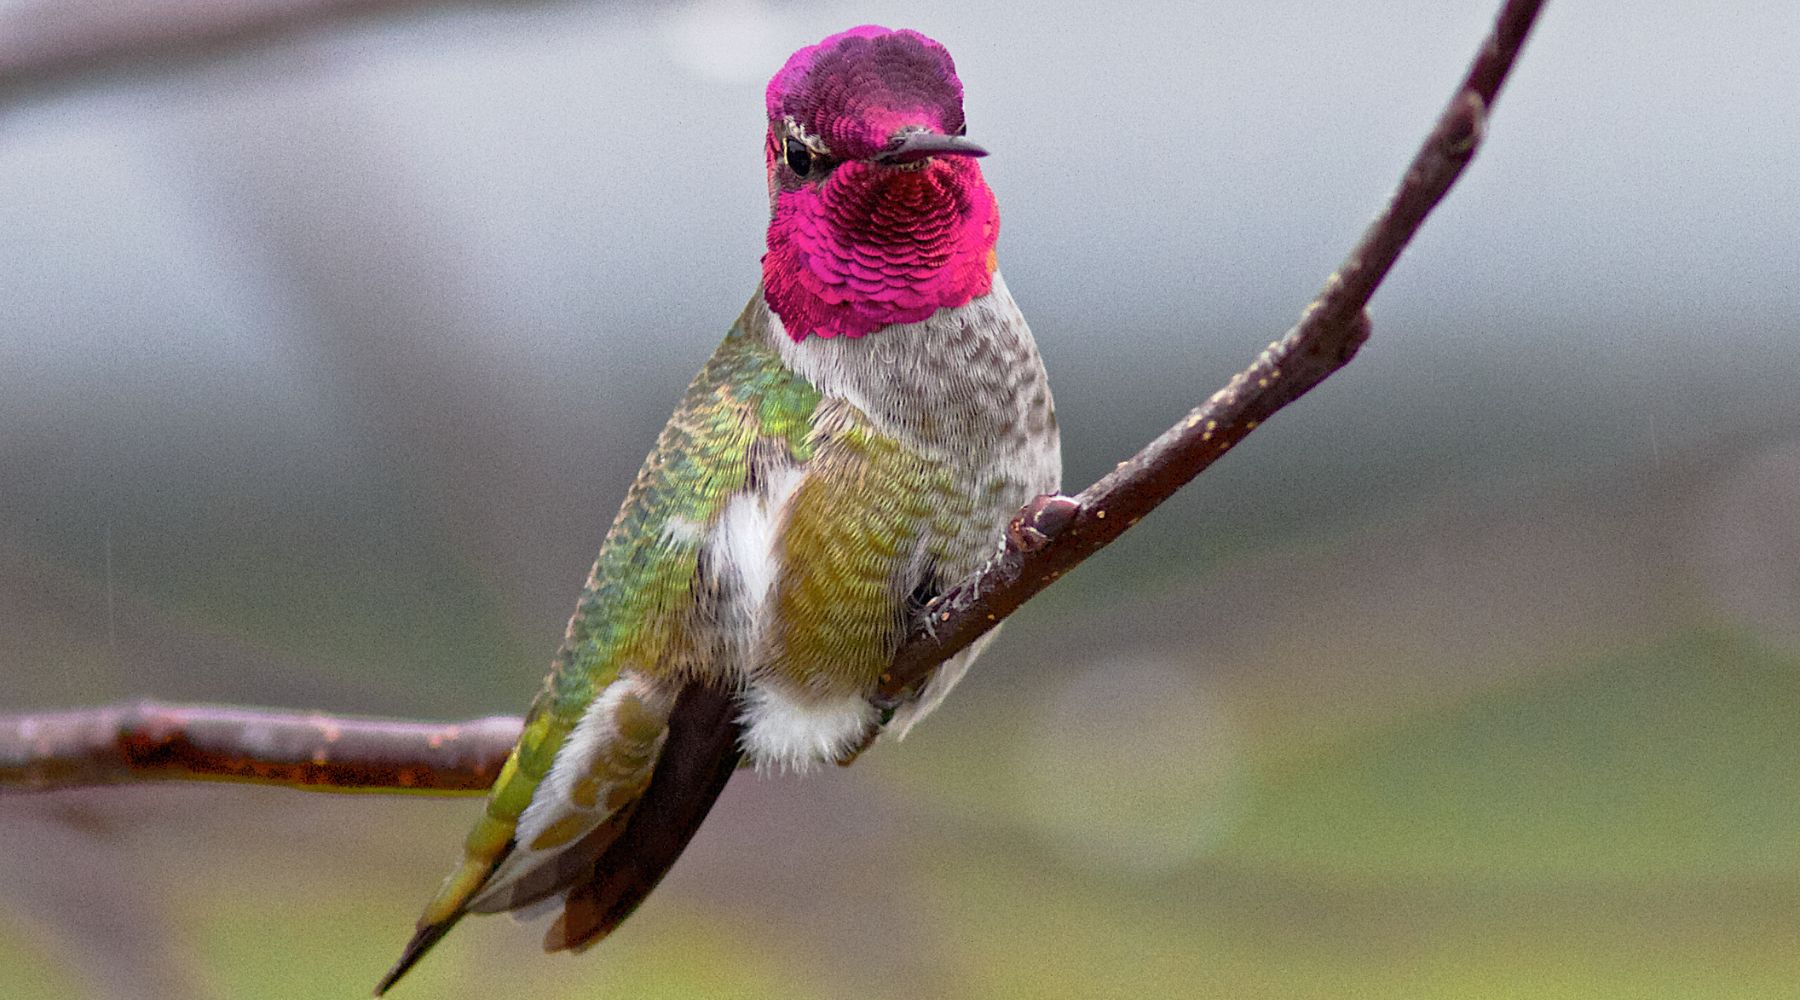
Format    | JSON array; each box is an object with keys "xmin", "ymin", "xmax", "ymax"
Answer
[{"xmin": 0, "ymin": 0, "xmax": 1800, "ymax": 1000}]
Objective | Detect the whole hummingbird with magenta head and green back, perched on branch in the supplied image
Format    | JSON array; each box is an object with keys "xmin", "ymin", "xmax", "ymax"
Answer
[{"xmin": 376, "ymin": 25, "xmax": 1062, "ymax": 995}]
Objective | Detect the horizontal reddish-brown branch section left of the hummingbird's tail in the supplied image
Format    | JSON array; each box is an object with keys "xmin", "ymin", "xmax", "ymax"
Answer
[{"xmin": 0, "ymin": 701, "xmax": 518, "ymax": 795}]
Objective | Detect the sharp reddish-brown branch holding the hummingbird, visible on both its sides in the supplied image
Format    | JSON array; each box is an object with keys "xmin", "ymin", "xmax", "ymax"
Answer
[{"xmin": 0, "ymin": 0, "xmax": 1543, "ymax": 793}]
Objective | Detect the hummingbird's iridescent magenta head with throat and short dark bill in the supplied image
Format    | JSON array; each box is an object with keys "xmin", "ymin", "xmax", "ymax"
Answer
[{"xmin": 763, "ymin": 25, "xmax": 999, "ymax": 340}]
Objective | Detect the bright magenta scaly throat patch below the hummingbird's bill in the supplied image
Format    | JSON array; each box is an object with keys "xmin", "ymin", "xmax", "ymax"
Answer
[{"xmin": 763, "ymin": 156, "xmax": 1001, "ymax": 340}]
